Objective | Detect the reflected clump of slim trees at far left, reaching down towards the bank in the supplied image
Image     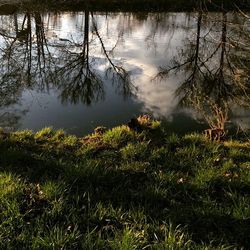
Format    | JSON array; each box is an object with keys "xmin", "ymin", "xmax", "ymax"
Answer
[{"xmin": 0, "ymin": 12, "xmax": 52, "ymax": 128}]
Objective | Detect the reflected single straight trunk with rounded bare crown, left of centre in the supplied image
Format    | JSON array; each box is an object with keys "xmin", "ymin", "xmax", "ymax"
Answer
[{"xmin": 56, "ymin": 11, "xmax": 104, "ymax": 105}]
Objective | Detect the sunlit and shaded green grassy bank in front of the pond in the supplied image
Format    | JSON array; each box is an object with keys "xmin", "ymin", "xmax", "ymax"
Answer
[{"xmin": 0, "ymin": 121, "xmax": 250, "ymax": 249}]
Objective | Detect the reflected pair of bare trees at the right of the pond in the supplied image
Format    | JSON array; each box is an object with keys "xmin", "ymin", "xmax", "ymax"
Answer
[{"xmin": 158, "ymin": 7, "xmax": 250, "ymax": 133}]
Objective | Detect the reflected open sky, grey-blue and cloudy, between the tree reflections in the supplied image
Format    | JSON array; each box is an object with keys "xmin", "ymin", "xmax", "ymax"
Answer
[{"xmin": 0, "ymin": 12, "xmax": 250, "ymax": 134}]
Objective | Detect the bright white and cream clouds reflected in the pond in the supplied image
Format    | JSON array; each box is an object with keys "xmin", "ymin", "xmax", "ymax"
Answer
[{"xmin": 43, "ymin": 13, "xmax": 189, "ymax": 118}]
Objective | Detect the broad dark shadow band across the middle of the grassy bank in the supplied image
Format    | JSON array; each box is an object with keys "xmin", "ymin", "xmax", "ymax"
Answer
[{"xmin": 0, "ymin": 129, "xmax": 250, "ymax": 249}]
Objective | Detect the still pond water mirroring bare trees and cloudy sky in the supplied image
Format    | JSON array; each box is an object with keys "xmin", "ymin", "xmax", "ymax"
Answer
[{"xmin": 0, "ymin": 11, "xmax": 250, "ymax": 135}]
